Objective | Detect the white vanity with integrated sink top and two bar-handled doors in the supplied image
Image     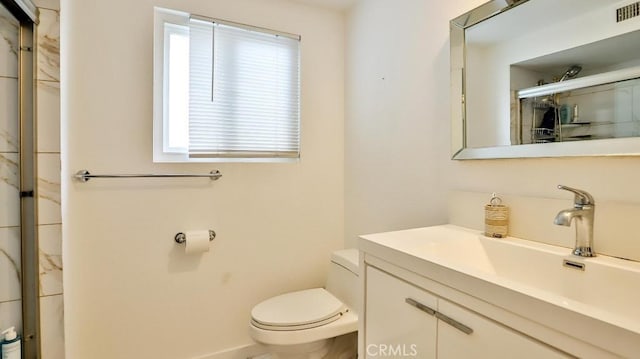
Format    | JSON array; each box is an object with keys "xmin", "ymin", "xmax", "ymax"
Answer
[{"xmin": 359, "ymin": 225, "xmax": 640, "ymax": 358}]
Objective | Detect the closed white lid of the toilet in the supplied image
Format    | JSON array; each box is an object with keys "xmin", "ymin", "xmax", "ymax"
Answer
[{"xmin": 251, "ymin": 288, "xmax": 346, "ymax": 330}]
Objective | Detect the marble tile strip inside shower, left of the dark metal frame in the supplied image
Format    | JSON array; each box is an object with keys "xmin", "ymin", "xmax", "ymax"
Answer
[{"xmin": 0, "ymin": 0, "xmax": 22, "ymax": 338}]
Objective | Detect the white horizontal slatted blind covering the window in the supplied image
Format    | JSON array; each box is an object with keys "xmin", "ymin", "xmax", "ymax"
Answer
[{"xmin": 188, "ymin": 19, "xmax": 300, "ymax": 158}]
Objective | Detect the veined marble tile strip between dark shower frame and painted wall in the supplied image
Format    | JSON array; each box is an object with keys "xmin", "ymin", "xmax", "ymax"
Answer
[{"xmin": 34, "ymin": 0, "xmax": 65, "ymax": 359}]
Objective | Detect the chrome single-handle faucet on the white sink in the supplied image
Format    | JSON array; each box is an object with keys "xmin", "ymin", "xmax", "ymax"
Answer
[{"xmin": 553, "ymin": 185, "xmax": 596, "ymax": 257}]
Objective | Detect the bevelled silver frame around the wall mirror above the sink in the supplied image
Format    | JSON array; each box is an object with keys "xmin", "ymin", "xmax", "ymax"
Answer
[{"xmin": 449, "ymin": 0, "xmax": 640, "ymax": 160}]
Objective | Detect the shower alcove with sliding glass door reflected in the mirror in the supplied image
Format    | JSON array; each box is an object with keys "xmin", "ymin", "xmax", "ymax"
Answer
[{"xmin": 510, "ymin": 27, "xmax": 640, "ymax": 145}]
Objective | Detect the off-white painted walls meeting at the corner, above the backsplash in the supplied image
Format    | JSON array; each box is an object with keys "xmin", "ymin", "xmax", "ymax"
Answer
[{"xmin": 62, "ymin": 0, "xmax": 640, "ymax": 358}]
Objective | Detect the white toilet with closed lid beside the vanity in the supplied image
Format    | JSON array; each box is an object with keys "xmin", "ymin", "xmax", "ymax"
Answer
[{"xmin": 249, "ymin": 249, "xmax": 359, "ymax": 359}]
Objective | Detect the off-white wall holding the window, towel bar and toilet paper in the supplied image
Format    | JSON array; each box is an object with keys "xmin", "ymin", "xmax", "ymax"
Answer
[{"xmin": 62, "ymin": 0, "xmax": 344, "ymax": 359}]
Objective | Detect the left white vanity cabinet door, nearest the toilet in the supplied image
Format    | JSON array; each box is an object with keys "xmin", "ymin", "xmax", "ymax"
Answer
[{"xmin": 364, "ymin": 266, "xmax": 437, "ymax": 359}]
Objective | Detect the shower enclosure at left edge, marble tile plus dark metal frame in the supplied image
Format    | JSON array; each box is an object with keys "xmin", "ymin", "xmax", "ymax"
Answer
[{"xmin": 0, "ymin": 0, "xmax": 40, "ymax": 359}]
